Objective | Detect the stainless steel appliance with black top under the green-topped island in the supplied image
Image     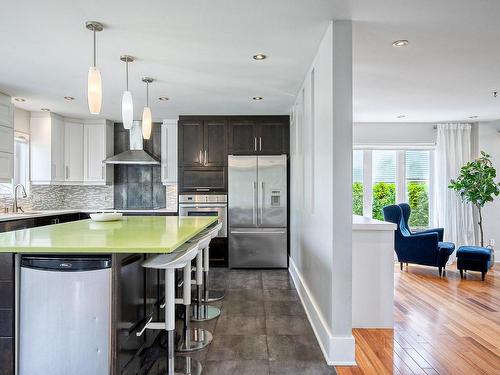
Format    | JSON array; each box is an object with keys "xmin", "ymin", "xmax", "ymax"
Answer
[{"xmin": 18, "ymin": 255, "xmax": 111, "ymax": 375}]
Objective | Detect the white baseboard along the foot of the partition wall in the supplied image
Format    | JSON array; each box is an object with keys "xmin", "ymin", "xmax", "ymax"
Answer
[{"xmin": 288, "ymin": 258, "xmax": 356, "ymax": 366}]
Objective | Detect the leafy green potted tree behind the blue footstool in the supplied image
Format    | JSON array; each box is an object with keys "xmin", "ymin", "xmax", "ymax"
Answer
[{"xmin": 448, "ymin": 151, "xmax": 500, "ymax": 263}]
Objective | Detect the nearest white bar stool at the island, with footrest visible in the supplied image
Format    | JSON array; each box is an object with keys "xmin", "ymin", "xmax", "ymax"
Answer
[{"xmin": 137, "ymin": 243, "xmax": 202, "ymax": 375}]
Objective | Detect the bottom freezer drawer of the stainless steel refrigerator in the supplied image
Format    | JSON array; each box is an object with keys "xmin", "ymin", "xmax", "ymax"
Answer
[{"xmin": 229, "ymin": 228, "xmax": 288, "ymax": 268}]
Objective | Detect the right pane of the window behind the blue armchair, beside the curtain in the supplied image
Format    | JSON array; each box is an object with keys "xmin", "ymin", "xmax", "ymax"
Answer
[{"xmin": 405, "ymin": 151, "xmax": 430, "ymax": 229}]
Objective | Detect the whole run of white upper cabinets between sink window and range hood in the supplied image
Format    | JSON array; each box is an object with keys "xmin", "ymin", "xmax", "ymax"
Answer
[{"xmin": 31, "ymin": 113, "xmax": 113, "ymax": 185}]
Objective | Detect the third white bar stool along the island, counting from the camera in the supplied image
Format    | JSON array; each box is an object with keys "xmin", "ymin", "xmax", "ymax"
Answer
[{"xmin": 188, "ymin": 230, "xmax": 220, "ymax": 322}]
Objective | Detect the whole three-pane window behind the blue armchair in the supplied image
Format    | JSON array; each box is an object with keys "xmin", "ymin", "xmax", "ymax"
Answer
[{"xmin": 352, "ymin": 149, "xmax": 433, "ymax": 230}]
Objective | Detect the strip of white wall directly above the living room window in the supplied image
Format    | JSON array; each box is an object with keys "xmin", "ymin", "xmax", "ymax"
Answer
[{"xmin": 353, "ymin": 122, "xmax": 437, "ymax": 146}]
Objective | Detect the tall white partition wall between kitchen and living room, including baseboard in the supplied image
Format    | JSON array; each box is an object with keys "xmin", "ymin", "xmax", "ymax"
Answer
[{"xmin": 290, "ymin": 21, "xmax": 354, "ymax": 364}]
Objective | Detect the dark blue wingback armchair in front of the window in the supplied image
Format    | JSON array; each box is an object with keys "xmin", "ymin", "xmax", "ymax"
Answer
[{"xmin": 383, "ymin": 204, "xmax": 455, "ymax": 277}]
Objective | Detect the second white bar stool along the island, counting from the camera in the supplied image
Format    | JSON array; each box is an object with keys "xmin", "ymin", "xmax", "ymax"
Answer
[{"xmin": 176, "ymin": 243, "xmax": 213, "ymax": 352}]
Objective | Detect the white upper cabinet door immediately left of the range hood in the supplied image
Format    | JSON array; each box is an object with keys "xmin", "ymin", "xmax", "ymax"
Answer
[{"xmin": 83, "ymin": 120, "xmax": 114, "ymax": 185}]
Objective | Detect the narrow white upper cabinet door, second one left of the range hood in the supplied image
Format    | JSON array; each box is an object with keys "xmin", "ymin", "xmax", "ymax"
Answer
[{"xmin": 64, "ymin": 119, "xmax": 84, "ymax": 184}]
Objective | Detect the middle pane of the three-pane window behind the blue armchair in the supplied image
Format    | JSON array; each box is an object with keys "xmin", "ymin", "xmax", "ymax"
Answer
[{"xmin": 372, "ymin": 150, "xmax": 396, "ymax": 220}]
